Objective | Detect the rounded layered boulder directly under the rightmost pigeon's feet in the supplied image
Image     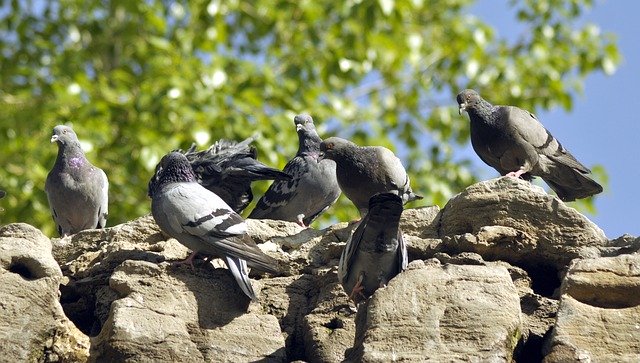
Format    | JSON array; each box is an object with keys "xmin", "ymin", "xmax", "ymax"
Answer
[{"xmin": 439, "ymin": 177, "xmax": 608, "ymax": 270}]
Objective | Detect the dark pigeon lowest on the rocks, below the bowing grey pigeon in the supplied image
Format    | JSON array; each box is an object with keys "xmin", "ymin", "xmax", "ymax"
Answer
[{"xmin": 338, "ymin": 191, "xmax": 408, "ymax": 303}]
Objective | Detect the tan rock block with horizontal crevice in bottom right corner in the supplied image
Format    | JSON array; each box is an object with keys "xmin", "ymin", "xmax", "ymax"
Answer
[{"xmin": 545, "ymin": 254, "xmax": 640, "ymax": 362}]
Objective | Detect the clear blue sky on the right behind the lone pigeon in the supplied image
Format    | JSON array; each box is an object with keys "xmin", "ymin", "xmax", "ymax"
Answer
[{"xmin": 470, "ymin": 0, "xmax": 640, "ymax": 238}]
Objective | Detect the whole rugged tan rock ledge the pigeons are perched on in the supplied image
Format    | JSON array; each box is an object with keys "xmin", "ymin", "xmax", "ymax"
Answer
[{"xmin": 0, "ymin": 178, "xmax": 640, "ymax": 362}]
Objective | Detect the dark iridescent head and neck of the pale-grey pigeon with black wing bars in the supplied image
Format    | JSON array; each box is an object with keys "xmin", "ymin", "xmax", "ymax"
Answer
[{"xmin": 147, "ymin": 151, "xmax": 196, "ymax": 197}]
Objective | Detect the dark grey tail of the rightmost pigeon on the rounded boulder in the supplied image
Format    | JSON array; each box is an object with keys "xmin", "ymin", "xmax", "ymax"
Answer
[{"xmin": 543, "ymin": 167, "xmax": 602, "ymax": 202}]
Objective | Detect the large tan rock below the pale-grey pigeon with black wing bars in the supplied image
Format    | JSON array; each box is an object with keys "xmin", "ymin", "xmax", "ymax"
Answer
[{"xmin": 92, "ymin": 261, "xmax": 285, "ymax": 362}]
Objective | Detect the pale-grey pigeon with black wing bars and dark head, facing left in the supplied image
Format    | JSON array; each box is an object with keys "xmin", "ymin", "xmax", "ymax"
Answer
[{"xmin": 149, "ymin": 152, "xmax": 277, "ymax": 300}]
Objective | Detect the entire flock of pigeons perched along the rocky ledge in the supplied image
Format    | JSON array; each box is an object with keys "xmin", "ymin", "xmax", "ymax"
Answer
[{"xmin": 31, "ymin": 90, "xmax": 602, "ymax": 302}]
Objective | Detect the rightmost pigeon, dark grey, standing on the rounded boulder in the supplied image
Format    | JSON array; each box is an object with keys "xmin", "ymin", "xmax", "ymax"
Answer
[{"xmin": 456, "ymin": 89, "xmax": 602, "ymax": 202}]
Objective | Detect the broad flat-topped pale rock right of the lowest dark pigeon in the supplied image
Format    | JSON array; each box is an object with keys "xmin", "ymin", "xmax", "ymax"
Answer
[{"xmin": 350, "ymin": 262, "xmax": 522, "ymax": 362}]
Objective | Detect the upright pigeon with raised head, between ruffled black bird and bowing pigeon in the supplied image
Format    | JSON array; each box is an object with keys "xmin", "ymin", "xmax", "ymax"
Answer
[{"xmin": 249, "ymin": 115, "xmax": 340, "ymax": 227}]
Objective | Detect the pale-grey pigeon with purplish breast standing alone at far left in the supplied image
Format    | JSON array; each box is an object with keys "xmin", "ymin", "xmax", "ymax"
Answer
[{"xmin": 44, "ymin": 125, "xmax": 109, "ymax": 237}]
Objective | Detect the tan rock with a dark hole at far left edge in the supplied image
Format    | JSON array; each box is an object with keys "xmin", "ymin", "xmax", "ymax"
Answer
[{"xmin": 0, "ymin": 223, "xmax": 89, "ymax": 362}]
